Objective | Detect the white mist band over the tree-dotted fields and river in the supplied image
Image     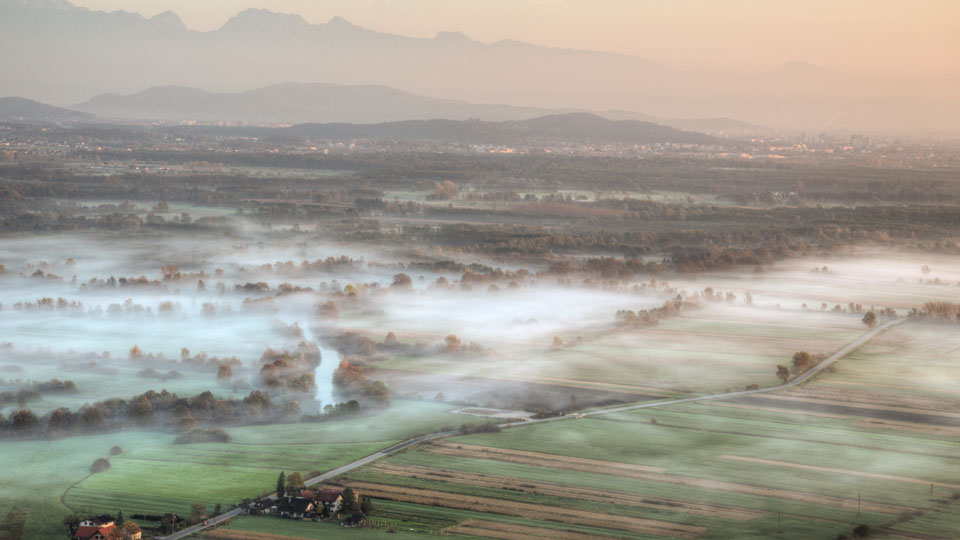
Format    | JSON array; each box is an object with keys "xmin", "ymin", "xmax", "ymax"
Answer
[{"xmin": 0, "ymin": 228, "xmax": 960, "ymax": 414}]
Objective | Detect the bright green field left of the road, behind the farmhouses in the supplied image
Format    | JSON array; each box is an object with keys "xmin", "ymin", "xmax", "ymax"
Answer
[{"xmin": 0, "ymin": 401, "xmax": 460, "ymax": 539}]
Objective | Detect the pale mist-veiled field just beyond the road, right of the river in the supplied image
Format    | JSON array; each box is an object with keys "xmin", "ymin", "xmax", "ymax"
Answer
[{"xmin": 376, "ymin": 305, "xmax": 867, "ymax": 394}]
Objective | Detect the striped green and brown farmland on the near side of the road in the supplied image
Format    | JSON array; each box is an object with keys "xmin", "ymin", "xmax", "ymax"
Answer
[{"xmin": 316, "ymin": 323, "xmax": 960, "ymax": 540}]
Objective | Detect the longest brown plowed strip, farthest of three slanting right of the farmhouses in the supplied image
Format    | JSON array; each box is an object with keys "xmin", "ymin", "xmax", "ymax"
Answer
[{"xmin": 425, "ymin": 442, "xmax": 912, "ymax": 515}]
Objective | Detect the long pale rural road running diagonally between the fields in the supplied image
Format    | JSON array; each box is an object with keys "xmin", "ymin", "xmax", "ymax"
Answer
[{"xmin": 161, "ymin": 319, "xmax": 907, "ymax": 540}]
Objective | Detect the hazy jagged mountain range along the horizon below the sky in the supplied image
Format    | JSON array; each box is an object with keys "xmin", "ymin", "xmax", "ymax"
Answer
[{"xmin": 0, "ymin": 0, "xmax": 960, "ymax": 132}]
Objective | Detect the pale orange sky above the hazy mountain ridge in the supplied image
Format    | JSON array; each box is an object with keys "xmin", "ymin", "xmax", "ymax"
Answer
[{"xmin": 74, "ymin": 0, "xmax": 960, "ymax": 77}]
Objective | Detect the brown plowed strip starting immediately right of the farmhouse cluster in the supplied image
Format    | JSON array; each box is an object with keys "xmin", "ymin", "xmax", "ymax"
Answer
[{"xmin": 344, "ymin": 480, "xmax": 707, "ymax": 538}]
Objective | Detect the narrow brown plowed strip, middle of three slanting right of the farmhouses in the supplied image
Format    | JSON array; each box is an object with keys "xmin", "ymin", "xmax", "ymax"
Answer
[{"xmin": 373, "ymin": 464, "xmax": 766, "ymax": 521}]
